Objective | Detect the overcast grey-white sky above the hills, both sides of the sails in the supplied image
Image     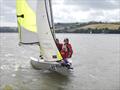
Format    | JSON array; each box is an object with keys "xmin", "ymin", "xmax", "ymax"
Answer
[{"xmin": 0, "ymin": 0, "xmax": 120, "ymax": 26}]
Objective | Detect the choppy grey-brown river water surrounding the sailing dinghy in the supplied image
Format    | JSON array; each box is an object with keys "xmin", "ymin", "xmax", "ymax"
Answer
[{"xmin": 0, "ymin": 33, "xmax": 120, "ymax": 90}]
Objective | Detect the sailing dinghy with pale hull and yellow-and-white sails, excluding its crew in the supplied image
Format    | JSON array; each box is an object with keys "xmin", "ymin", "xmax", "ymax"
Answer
[{"xmin": 16, "ymin": 0, "xmax": 71, "ymax": 75}]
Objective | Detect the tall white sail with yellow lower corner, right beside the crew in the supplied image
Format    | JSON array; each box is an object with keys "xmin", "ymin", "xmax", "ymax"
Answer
[{"xmin": 36, "ymin": 0, "xmax": 62, "ymax": 61}]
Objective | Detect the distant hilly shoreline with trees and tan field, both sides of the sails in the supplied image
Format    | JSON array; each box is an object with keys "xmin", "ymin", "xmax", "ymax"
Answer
[{"xmin": 0, "ymin": 22, "xmax": 120, "ymax": 34}]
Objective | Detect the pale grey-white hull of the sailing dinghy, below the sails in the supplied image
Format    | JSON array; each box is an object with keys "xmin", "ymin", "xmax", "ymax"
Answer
[{"xmin": 31, "ymin": 58, "xmax": 72, "ymax": 75}]
